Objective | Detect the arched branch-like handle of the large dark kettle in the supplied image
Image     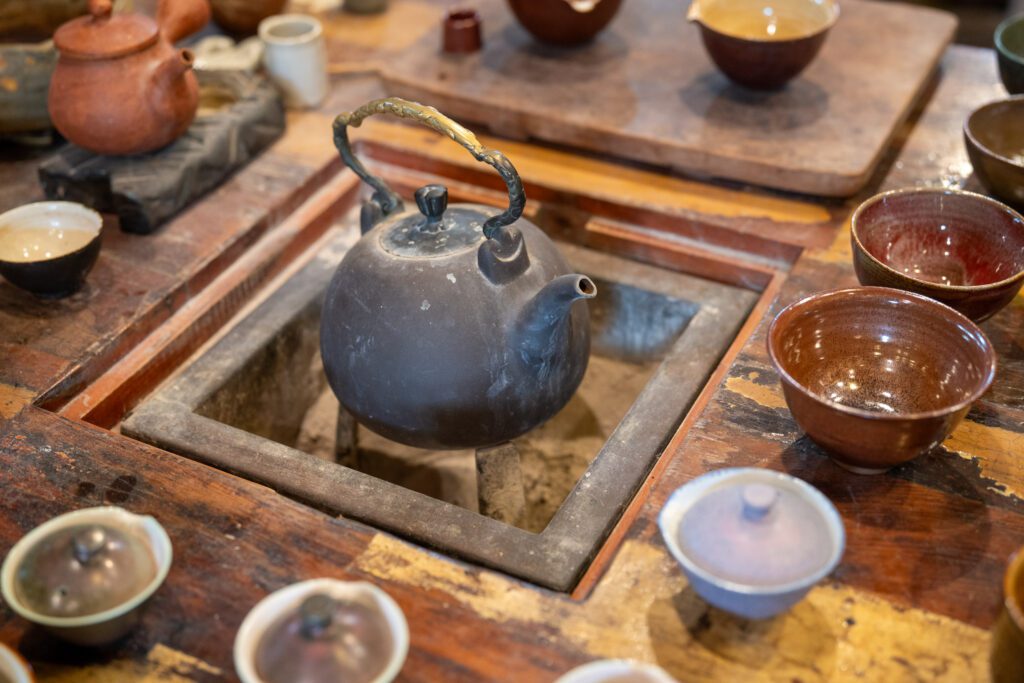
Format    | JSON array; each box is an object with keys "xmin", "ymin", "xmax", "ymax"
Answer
[{"xmin": 334, "ymin": 97, "xmax": 526, "ymax": 240}]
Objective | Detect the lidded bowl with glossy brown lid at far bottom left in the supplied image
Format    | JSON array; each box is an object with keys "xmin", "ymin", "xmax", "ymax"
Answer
[{"xmin": 0, "ymin": 507, "xmax": 171, "ymax": 645}]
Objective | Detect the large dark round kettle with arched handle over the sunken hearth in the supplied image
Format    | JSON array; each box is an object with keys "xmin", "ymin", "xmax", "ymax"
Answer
[{"xmin": 321, "ymin": 97, "xmax": 597, "ymax": 449}]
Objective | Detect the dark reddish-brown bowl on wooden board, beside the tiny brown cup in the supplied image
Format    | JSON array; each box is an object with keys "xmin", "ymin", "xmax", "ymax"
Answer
[{"xmin": 508, "ymin": 0, "xmax": 622, "ymax": 47}]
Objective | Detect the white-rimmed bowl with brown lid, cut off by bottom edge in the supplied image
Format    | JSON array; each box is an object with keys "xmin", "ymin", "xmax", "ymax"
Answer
[{"xmin": 234, "ymin": 579, "xmax": 409, "ymax": 683}]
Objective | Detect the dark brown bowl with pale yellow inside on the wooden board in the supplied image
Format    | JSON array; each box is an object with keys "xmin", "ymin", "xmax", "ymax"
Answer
[{"xmin": 687, "ymin": 0, "xmax": 839, "ymax": 90}]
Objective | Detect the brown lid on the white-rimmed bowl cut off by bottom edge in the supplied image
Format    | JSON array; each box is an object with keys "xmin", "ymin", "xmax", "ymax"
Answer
[{"xmin": 255, "ymin": 593, "xmax": 395, "ymax": 683}]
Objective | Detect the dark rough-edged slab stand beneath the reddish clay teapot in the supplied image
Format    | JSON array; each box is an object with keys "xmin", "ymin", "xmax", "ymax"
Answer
[{"xmin": 39, "ymin": 72, "xmax": 285, "ymax": 234}]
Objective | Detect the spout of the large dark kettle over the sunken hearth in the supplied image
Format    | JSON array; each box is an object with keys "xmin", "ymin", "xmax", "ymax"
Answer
[{"xmin": 519, "ymin": 273, "xmax": 597, "ymax": 361}]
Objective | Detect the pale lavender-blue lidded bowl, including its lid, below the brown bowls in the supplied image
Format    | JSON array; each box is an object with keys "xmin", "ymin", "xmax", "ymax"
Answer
[{"xmin": 658, "ymin": 468, "xmax": 846, "ymax": 618}]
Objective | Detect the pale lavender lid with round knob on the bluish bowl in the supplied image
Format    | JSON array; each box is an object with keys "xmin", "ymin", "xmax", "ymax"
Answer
[{"xmin": 678, "ymin": 476, "xmax": 835, "ymax": 587}]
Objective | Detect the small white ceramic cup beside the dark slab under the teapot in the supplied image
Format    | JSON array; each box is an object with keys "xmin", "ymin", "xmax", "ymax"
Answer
[{"xmin": 259, "ymin": 14, "xmax": 328, "ymax": 109}]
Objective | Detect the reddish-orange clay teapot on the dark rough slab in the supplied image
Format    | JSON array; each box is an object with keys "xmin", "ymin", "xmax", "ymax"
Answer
[{"xmin": 49, "ymin": 0, "xmax": 210, "ymax": 155}]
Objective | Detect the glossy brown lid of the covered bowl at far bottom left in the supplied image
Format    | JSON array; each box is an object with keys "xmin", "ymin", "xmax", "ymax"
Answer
[{"xmin": 14, "ymin": 523, "xmax": 157, "ymax": 617}]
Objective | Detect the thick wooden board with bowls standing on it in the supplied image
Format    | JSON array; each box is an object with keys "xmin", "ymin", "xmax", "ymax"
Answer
[{"xmin": 382, "ymin": 0, "xmax": 956, "ymax": 197}]
